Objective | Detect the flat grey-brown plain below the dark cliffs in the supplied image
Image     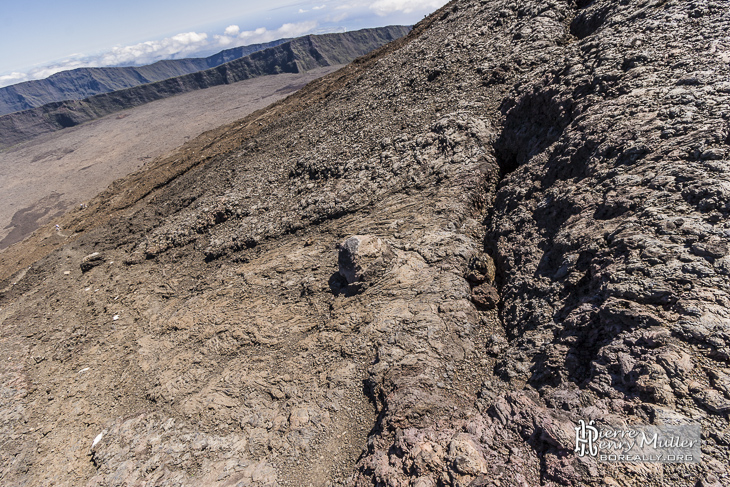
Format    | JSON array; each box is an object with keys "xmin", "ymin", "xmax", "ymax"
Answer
[{"xmin": 0, "ymin": 65, "xmax": 342, "ymax": 249}]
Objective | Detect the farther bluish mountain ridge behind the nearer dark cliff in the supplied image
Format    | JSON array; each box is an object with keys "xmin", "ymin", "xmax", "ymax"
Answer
[{"xmin": 0, "ymin": 39, "xmax": 291, "ymax": 115}]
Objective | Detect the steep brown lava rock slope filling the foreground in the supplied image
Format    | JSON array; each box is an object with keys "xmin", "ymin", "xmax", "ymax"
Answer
[{"xmin": 0, "ymin": 0, "xmax": 730, "ymax": 487}]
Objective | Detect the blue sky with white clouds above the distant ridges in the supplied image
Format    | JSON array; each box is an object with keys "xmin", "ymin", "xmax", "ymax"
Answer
[{"xmin": 0, "ymin": 0, "xmax": 447, "ymax": 87}]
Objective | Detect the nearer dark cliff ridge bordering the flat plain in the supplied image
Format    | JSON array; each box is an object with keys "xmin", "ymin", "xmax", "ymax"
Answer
[{"xmin": 0, "ymin": 26, "xmax": 410, "ymax": 149}]
